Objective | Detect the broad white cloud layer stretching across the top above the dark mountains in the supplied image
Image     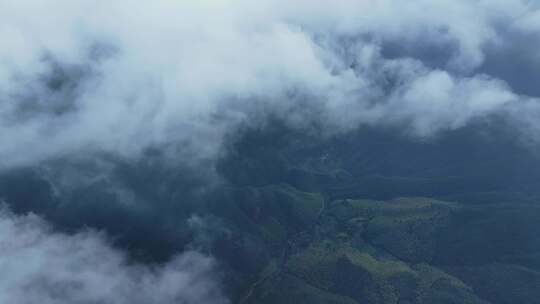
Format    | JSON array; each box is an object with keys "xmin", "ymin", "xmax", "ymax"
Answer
[{"xmin": 0, "ymin": 0, "xmax": 540, "ymax": 167}]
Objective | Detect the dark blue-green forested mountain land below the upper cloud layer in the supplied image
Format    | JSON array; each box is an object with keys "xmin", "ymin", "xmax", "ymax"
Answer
[{"xmin": 0, "ymin": 124, "xmax": 540, "ymax": 304}]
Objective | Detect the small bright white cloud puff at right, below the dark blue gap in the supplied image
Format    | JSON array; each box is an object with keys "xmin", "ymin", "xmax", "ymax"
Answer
[{"xmin": 387, "ymin": 70, "xmax": 519, "ymax": 135}]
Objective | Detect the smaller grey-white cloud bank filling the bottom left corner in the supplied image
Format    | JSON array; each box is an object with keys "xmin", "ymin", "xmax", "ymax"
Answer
[{"xmin": 0, "ymin": 210, "xmax": 228, "ymax": 304}]
